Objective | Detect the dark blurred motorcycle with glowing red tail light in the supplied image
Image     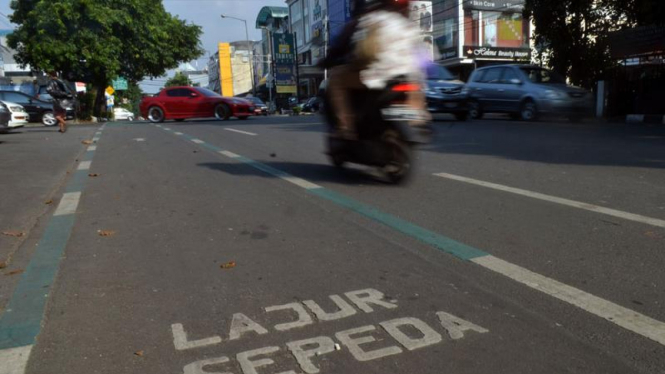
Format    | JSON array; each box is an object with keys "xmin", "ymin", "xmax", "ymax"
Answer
[{"xmin": 322, "ymin": 80, "xmax": 431, "ymax": 184}]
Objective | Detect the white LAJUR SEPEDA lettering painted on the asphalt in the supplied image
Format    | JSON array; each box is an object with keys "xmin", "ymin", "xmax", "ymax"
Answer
[{"xmin": 171, "ymin": 288, "xmax": 489, "ymax": 374}]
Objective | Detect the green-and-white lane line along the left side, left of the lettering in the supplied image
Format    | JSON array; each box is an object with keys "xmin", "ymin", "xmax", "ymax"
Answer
[{"xmin": 0, "ymin": 126, "xmax": 104, "ymax": 374}]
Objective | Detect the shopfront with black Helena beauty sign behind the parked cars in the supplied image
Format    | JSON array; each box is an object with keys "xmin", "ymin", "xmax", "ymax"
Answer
[{"xmin": 433, "ymin": 0, "xmax": 531, "ymax": 80}]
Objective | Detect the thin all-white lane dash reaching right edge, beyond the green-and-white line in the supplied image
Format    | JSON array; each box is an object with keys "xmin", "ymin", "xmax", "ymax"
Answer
[{"xmin": 434, "ymin": 173, "xmax": 665, "ymax": 228}]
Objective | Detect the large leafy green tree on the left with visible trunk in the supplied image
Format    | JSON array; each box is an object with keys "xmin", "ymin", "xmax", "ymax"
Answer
[{"xmin": 8, "ymin": 0, "xmax": 203, "ymax": 115}]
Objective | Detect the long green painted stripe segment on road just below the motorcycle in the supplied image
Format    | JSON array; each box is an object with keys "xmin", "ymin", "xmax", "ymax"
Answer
[{"xmin": 309, "ymin": 188, "xmax": 489, "ymax": 260}]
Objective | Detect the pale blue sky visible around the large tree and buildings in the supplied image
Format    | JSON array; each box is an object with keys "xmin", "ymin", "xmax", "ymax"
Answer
[{"xmin": 0, "ymin": 0, "xmax": 286, "ymax": 91}]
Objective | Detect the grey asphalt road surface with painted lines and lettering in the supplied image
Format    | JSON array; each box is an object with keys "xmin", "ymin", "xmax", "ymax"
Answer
[{"xmin": 0, "ymin": 117, "xmax": 665, "ymax": 374}]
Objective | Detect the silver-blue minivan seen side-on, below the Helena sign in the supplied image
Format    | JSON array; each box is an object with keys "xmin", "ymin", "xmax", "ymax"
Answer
[{"xmin": 467, "ymin": 65, "xmax": 593, "ymax": 121}]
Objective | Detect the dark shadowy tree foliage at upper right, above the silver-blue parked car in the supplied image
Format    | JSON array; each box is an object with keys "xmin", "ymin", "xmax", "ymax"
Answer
[{"xmin": 525, "ymin": 0, "xmax": 665, "ymax": 88}]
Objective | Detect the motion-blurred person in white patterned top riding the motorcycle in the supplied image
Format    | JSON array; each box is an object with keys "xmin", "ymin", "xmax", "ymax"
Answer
[{"xmin": 321, "ymin": 0, "xmax": 425, "ymax": 139}]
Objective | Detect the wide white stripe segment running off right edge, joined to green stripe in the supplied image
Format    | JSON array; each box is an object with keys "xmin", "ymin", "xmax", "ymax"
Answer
[{"xmin": 471, "ymin": 255, "xmax": 665, "ymax": 345}]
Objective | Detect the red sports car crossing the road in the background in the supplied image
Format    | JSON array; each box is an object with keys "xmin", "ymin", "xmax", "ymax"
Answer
[{"xmin": 140, "ymin": 86, "xmax": 254, "ymax": 123}]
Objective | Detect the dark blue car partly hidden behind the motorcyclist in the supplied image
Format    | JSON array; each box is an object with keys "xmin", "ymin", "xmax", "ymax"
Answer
[{"xmin": 425, "ymin": 64, "xmax": 469, "ymax": 121}]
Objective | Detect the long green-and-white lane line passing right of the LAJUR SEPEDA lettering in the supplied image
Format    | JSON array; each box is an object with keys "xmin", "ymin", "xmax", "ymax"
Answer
[{"xmin": 154, "ymin": 125, "xmax": 665, "ymax": 345}]
